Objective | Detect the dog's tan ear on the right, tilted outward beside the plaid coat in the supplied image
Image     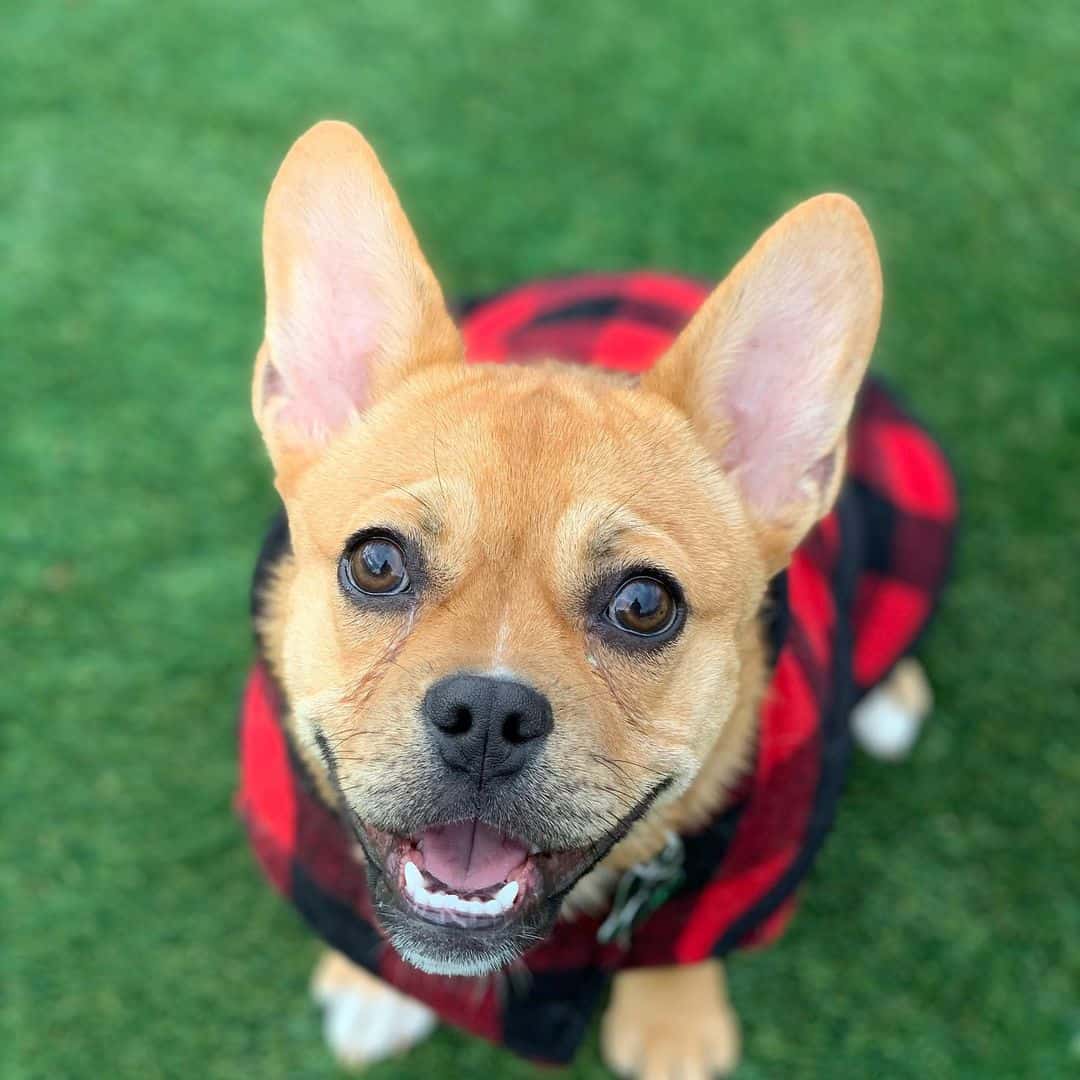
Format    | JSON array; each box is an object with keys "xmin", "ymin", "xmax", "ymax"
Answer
[{"xmin": 642, "ymin": 194, "xmax": 881, "ymax": 571}]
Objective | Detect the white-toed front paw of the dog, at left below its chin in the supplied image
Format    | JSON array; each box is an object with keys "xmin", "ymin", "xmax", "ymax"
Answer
[{"xmin": 311, "ymin": 951, "xmax": 436, "ymax": 1068}]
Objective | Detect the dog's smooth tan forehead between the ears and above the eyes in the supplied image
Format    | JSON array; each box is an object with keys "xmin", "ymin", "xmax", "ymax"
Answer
[{"xmin": 291, "ymin": 365, "xmax": 742, "ymax": 559}]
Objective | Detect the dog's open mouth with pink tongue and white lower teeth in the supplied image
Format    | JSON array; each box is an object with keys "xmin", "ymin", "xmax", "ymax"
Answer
[{"xmin": 365, "ymin": 819, "xmax": 592, "ymax": 931}]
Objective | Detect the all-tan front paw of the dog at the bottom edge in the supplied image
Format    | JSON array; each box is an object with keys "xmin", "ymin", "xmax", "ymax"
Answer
[{"xmin": 600, "ymin": 960, "xmax": 739, "ymax": 1080}]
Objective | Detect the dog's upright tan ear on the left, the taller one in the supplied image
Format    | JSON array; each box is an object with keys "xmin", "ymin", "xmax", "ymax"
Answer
[{"xmin": 252, "ymin": 122, "xmax": 462, "ymax": 485}]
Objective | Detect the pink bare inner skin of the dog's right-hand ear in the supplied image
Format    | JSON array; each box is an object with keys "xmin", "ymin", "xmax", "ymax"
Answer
[{"xmin": 716, "ymin": 283, "xmax": 843, "ymax": 516}]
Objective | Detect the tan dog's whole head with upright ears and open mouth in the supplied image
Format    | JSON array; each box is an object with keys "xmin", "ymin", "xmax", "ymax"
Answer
[{"xmin": 254, "ymin": 124, "xmax": 880, "ymax": 973}]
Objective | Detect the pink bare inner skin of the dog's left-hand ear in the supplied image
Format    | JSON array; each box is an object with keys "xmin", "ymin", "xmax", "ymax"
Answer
[{"xmin": 267, "ymin": 222, "xmax": 387, "ymax": 436}]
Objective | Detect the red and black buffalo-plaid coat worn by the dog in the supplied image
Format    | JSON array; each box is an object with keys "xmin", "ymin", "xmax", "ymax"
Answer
[{"xmin": 238, "ymin": 273, "xmax": 957, "ymax": 1062}]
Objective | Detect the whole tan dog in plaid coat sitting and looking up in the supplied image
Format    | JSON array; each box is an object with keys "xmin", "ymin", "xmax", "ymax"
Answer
[{"xmin": 240, "ymin": 122, "xmax": 955, "ymax": 1077}]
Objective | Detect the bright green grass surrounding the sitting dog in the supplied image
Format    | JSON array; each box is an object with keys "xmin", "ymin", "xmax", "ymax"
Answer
[{"xmin": 0, "ymin": 0, "xmax": 1080, "ymax": 1080}]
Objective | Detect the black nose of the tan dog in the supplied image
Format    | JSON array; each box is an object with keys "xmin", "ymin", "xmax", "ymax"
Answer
[{"xmin": 423, "ymin": 675, "xmax": 554, "ymax": 786}]
